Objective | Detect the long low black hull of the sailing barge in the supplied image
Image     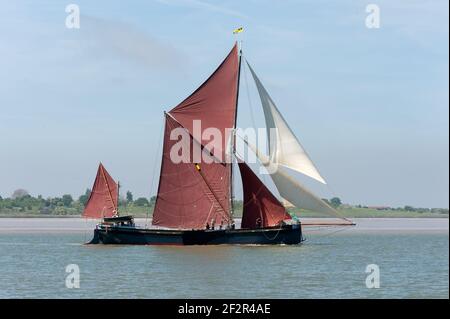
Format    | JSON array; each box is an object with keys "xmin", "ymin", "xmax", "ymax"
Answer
[{"xmin": 89, "ymin": 224, "xmax": 302, "ymax": 245}]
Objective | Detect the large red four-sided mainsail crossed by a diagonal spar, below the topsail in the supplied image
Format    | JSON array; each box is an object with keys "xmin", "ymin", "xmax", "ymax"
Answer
[{"xmin": 152, "ymin": 115, "xmax": 230, "ymax": 229}]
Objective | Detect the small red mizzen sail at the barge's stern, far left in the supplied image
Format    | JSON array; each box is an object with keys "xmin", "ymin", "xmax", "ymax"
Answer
[{"xmin": 83, "ymin": 163, "xmax": 119, "ymax": 218}]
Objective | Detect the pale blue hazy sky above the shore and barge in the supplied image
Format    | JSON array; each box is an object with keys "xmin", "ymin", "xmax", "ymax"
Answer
[{"xmin": 0, "ymin": 0, "xmax": 449, "ymax": 208}]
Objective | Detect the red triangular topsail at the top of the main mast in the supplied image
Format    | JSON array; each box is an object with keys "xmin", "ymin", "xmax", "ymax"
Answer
[{"xmin": 169, "ymin": 44, "xmax": 239, "ymax": 161}]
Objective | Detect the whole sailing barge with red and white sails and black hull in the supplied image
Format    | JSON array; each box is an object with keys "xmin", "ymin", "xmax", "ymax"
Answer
[{"xmin": 83, "ymin": 44, "xmax": 351, "ymax": 245}]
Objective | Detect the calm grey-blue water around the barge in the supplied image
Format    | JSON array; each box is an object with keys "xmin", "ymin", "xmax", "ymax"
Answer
[{"xmin": 0, "ymin": 219, "xmax": 449, "ymax": 298}]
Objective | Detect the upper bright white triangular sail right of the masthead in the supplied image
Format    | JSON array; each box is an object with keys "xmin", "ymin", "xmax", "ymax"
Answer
[{"xmin": 247, "ymin": 62, "xmax": 326, "ymax": 184}]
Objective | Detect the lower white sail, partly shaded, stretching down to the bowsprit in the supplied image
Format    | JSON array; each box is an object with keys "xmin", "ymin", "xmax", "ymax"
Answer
[{"xmin": 246, "ymin": 142, "xmax": 342, "ymax": 218}]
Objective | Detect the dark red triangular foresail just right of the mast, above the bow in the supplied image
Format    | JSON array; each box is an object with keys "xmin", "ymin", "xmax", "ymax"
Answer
[{"xmin": 239, "ymin": 162, "xmax": 291, "ymax": 228}]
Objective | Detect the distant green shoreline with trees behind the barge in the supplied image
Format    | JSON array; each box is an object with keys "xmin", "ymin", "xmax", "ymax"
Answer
[{"xmin": 0, "ymin": 195, "xmax": 449, "ymax": 219}]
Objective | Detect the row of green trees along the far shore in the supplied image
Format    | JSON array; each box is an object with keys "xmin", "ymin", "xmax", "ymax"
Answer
[{"xmin": 0, "ymin": 189, "xmax": 448, "ymax": 215}]
